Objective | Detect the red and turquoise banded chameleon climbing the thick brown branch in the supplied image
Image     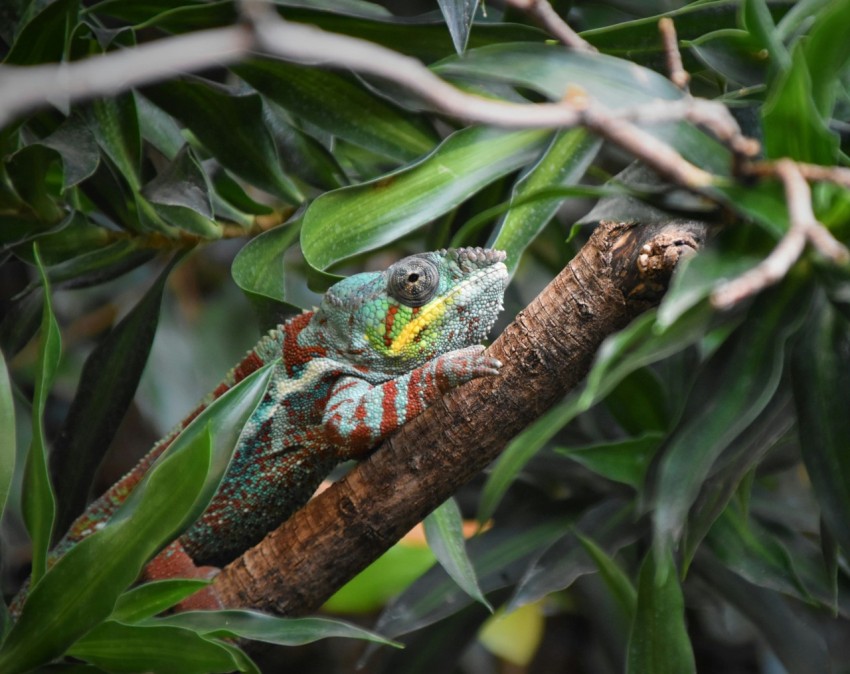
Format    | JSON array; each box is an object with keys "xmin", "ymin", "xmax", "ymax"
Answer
[{"xmin": 58, "ymin": 248, "xmax": 508, "ymax": 565}]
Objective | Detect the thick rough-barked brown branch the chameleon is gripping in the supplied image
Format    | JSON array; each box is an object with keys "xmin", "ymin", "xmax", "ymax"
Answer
[{"xmin": 213, "ymin": 222, "xmax": 704, "ymax": 615}]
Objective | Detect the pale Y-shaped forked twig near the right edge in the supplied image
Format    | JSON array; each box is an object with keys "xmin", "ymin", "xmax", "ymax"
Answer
[{"xmin": 711, "ymin": 159, "xmax": 850, "ymax": 309}]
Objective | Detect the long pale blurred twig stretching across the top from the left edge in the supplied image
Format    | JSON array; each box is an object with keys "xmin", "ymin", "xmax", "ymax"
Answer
[{"xmin": 0, "ymin": 3, "xmax": 731, "ymax": 188}]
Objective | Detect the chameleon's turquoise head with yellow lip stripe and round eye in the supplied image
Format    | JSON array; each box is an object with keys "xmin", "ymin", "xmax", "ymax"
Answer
[{"xmin": 319, "ymin": 248, "xmax": 508, "ymax": 374}]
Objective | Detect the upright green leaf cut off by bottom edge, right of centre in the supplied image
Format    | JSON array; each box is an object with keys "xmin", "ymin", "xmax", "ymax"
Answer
[{"xmin": 626, "ymin": 550, "xmax": 696, "ymax": 674}]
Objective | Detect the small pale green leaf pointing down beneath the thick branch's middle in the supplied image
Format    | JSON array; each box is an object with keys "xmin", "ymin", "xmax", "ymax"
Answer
[{"xmin": 424, "ymin": 498, "xmax": 493, "ymax": 611}]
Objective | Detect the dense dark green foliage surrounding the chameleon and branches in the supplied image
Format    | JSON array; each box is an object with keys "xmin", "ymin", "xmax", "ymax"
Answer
[{"xmin": 0, "ymin": 0, "xmax": 850, "ymax": 674}]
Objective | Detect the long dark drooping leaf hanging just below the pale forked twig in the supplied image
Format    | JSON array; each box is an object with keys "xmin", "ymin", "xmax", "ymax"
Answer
[{"xmin": 653, "ymin": 281, "xmax": 807, "ymax": 549}]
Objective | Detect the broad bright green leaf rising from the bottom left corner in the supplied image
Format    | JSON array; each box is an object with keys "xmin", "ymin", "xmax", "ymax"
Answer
[{"xmin": 0, "ymin": 426, "xmax": 210, "ymax": 673}]
